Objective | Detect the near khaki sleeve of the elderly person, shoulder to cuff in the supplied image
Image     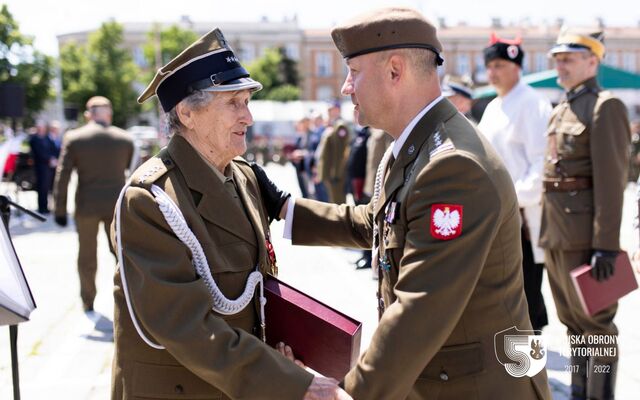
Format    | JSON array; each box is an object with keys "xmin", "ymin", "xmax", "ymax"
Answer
[{"xmin": 120, "ymin": 187, "xmax": 312, "ymax": 399}]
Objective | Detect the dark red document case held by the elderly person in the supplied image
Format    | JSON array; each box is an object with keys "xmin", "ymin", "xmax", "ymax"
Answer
[{"xmin": 264, "ymin": 276, "xmax": 362, "ymax": 380}]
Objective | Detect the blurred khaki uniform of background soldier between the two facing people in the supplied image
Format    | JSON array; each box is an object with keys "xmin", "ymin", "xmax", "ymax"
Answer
[{"xmin": 317, "ymin": 121, "xmax": 351, "ymax": 204}]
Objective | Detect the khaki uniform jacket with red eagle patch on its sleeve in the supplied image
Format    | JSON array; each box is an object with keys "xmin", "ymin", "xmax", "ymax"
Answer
[{"xmin": 292, "ymin": 99, "xmax": 550, "ymax": 400}]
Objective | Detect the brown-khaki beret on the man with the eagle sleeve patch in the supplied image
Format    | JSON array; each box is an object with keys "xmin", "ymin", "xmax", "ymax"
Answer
[{"xmin": 331, "ymin": 7, "xmax": 443, "ymax": 65}]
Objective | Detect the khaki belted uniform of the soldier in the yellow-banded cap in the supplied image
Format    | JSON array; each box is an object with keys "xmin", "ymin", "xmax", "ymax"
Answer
[{"xmin": 540, "ymin": 78, "xmax": 630, "ymax": 361}]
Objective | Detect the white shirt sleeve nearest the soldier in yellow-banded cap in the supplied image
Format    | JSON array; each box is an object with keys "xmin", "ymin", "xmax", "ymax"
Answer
[{"xmin": 514, "ymin": 99, "xmax": 551, "ymax": 207}]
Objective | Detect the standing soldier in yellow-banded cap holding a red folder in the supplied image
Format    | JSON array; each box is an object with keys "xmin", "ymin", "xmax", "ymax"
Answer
[{"xmin": 540, "ymin": 30, "xmax": 630, "ymax": 399}]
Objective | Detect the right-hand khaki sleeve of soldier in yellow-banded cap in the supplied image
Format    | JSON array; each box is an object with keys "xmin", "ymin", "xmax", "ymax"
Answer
[{"xmin": 591, "ymin": 98, "xmax": 631, "ymax": 250}]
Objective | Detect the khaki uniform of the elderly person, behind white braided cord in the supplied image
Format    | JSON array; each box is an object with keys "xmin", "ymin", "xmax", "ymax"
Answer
[{"xmin": 112, "ymin": 136, "xmax": 312, "ymax": 400}]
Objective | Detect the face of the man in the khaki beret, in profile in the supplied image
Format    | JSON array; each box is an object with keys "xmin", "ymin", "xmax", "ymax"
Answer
[{"xmin": 342, "ymin": 53, "xmax": 386, "ymax": 127}]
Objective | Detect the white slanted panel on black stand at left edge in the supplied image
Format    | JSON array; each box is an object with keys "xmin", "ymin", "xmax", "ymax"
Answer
[{"xmin": 0, "ymin": 221, "xmax": 36, "ymax": 326}]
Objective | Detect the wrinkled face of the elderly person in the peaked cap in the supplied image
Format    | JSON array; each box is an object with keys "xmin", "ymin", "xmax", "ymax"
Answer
[{"xmin": 185, "ymin": 90, "xmax": 253, "ymax": 167}]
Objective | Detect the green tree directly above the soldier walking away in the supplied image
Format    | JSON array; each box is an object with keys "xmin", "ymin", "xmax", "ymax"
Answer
[{"xmin": 60, "ymin": 21, "xmax": 140, "ymax": 126}]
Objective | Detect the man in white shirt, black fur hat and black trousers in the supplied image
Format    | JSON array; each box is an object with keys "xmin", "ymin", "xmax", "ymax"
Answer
[{"xmin": 478, "ymin": 35, "xmax": 551, "ymax": 330}]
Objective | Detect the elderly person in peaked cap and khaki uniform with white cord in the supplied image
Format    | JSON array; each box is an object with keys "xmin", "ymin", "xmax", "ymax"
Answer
[{"xmin": 112, "ymin": 29, "xmax": 348, "ymax": 399}]
